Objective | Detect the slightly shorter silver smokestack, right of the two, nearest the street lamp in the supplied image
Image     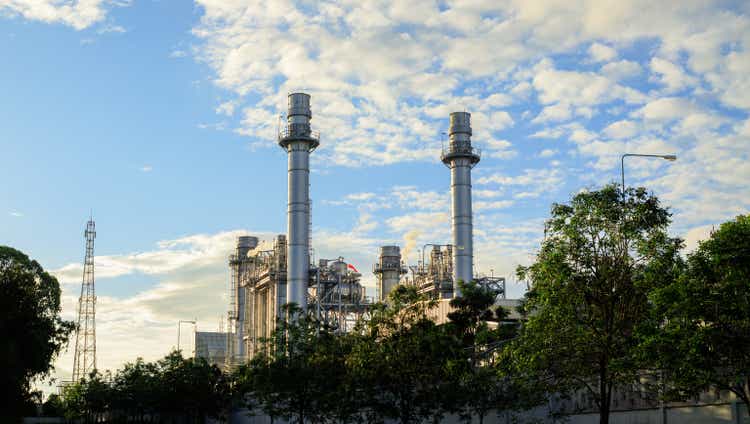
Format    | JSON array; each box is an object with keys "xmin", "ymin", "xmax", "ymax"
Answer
[{"xmin": 441, "ymin": 112, "xmax": 479, "ymax": 297}]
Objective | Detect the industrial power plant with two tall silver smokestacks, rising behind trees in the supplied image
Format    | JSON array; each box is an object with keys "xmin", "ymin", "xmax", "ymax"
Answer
[{"xmin": 225, "ymin": 93, "xmax": 508, "ymax": 368}]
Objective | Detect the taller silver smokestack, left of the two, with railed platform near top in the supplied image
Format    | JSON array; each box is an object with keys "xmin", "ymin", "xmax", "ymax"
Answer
[{"xmin": 279, "ymin": 93, "xmax": 320, "ymax": 309}]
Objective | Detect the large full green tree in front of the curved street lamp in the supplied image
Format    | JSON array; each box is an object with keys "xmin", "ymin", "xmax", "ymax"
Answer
[{"xmin": 512, "ymin": 185, "xmax": 682, "ymax": 424}]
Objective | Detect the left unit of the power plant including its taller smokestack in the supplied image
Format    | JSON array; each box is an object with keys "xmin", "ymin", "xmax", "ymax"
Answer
[{"xmin": 226, "ymin": 93, "xmax": 368, "ymax": 368}]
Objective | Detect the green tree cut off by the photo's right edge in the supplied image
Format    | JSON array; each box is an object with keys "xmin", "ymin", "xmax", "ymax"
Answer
[{"xmin": 644, "ymin": 215, "xmax": 750, "ymax": 408}]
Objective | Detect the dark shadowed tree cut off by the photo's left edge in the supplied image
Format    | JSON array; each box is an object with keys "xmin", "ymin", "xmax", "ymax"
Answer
[{"xmin": 0, "ymin": 246, "xmax": 75, "ymax": 421}]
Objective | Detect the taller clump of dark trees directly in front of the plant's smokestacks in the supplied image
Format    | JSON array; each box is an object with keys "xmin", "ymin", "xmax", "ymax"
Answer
[{"xmin": 234, "ymin": 283, "xmax": 520, "ymax": 423}]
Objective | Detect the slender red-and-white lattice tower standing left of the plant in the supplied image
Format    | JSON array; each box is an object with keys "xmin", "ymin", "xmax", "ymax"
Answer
[{"xmin": 73, "ymin": 218, "xmax": 96, "ymax": 382}]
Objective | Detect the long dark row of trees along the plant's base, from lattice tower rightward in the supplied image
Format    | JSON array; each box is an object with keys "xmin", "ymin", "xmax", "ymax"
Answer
[{"xmin": 55, "ymin": 283, "xmax": 517, "ymax": 423}]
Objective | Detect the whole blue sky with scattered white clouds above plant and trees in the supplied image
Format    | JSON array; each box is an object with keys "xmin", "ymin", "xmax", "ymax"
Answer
[{"xmin": 0, "ymin": 0, "xmax": 750, "ymax": 388}]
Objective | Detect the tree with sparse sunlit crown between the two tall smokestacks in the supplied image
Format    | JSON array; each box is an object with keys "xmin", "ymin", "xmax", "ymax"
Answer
[{"xmin": 347, "ymin": 286, "xmax": 462, "ymax": 423}]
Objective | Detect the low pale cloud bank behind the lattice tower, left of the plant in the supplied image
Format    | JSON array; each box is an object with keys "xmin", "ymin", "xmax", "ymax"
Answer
[{"xmin": 52, "ymin": 231, "xmax": 262, "ymax": 378}]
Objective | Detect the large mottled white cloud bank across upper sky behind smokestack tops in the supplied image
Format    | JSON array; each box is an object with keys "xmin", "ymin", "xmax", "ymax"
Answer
[{"xmin": 193, "ymin": 0, "xmax": 750, "ymax": 166}]
